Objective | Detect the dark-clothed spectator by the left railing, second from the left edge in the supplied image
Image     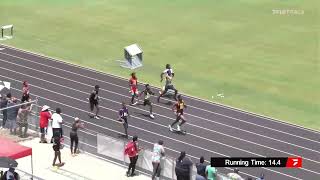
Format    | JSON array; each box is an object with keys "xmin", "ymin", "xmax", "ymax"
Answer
[{"xmin": 6, "ymin": 97, "xmax": 20, "ymax": 135}]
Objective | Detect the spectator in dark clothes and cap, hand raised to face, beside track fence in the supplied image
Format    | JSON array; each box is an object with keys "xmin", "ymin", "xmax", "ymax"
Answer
[{"xmin": 70, "ymin": 117, "xmax": 84, "ymax": 156}]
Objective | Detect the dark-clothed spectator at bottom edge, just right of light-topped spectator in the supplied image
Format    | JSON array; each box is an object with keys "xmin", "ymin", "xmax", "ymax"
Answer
[{"xmin": 175, "ymin": 151, "xmax": 192, "ymax": 180}]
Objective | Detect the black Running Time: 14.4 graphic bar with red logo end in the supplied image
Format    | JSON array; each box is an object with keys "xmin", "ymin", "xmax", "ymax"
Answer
[{"xmin": 211, "ymin": 157, "xmax": 302, "ymax": 168}]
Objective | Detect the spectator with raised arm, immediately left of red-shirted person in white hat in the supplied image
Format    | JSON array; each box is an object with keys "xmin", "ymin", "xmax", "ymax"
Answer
[{"xmin": 17, "ymin": 105, "xmax": 33, "ymax": 138}]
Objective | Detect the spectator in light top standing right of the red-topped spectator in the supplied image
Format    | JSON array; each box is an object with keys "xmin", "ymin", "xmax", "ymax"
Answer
[{"xmin": 152, "ymin": 140, "xmax": 165, "ymax": 180}]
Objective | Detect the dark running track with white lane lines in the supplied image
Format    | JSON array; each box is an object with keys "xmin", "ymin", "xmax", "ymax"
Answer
[{"xmin": 0, "ymin": 45, "xmax": 320, "ymax": 180}]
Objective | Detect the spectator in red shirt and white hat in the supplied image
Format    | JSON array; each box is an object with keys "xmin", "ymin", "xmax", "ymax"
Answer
[{"xmin": 40, "ymin": 105, "xmax": 51, "ymax": 143}]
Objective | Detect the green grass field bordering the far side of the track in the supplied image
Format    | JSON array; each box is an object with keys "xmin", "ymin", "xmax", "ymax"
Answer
[{"xmin": 0, "ymin": 0, "xmax": 320, "ymax": 130}]
